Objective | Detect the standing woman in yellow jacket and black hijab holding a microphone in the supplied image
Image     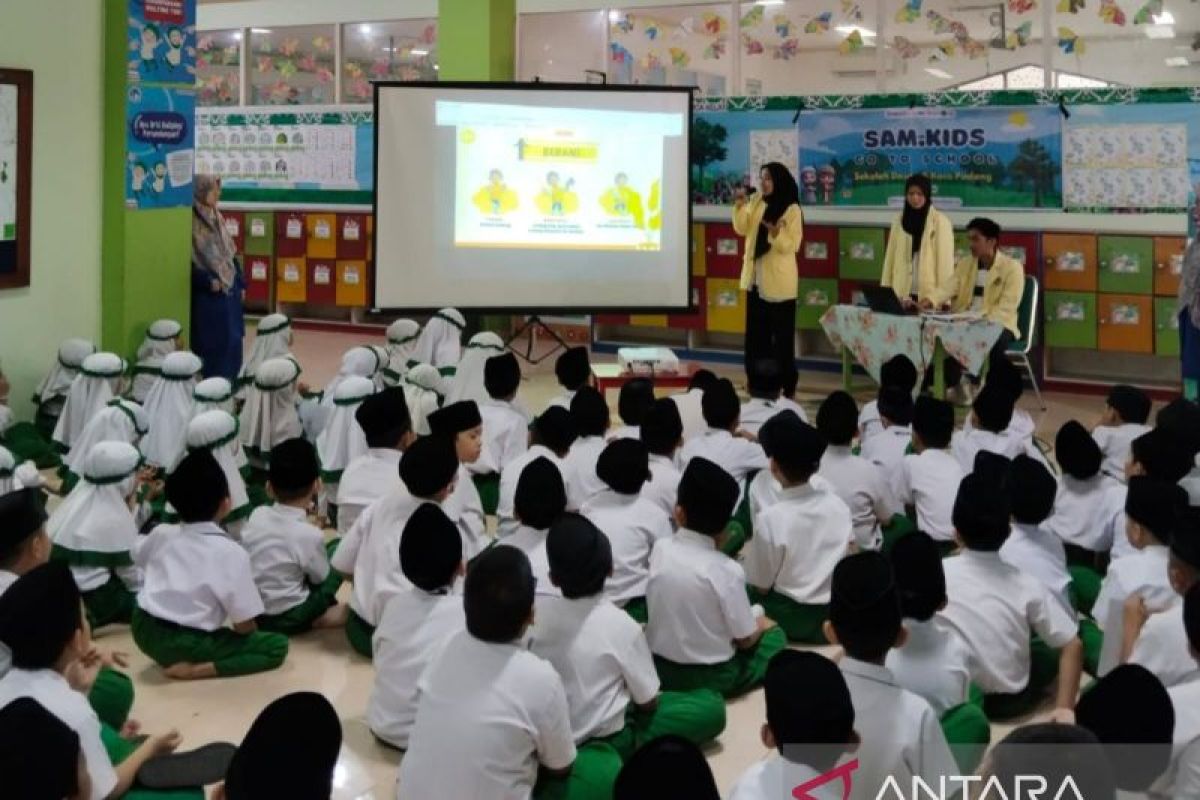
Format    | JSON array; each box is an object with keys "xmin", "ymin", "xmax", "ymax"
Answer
[{"xmin": 733, "ymin": 162, "xmax": 804, "ymax": 397}]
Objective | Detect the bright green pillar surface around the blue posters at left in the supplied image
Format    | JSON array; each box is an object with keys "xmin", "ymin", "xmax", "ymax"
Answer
[{"xmin": 102, "ymin": 0, "xmax": 192, "ymax": 357}]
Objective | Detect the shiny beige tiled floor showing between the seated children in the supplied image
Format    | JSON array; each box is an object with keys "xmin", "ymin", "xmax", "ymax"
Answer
[{"xmin": 84, "ymin": 331, "xmax": 1102, "ymax": 800}]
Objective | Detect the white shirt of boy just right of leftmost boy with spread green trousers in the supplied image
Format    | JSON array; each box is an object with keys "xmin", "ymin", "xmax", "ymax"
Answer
[{"xmin": 241, "ymin": 504, "xmax": 329, "ymax": 614}]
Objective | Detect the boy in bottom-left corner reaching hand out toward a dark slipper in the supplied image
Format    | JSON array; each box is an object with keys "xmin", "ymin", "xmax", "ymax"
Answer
[{"xmin": 0, "ymin": 564, "xmax": 187, "ymax": 800}]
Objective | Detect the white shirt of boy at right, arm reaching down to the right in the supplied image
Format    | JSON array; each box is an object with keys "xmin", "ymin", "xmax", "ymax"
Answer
[{"xmin": 942, "ymin": 551, "xmax": 1079, "ymax": 694}]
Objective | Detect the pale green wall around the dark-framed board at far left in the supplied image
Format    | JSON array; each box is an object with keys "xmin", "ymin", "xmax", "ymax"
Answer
[{"xmin": 0, "ymin": 0, "xmax": 103, "ymax": 419}]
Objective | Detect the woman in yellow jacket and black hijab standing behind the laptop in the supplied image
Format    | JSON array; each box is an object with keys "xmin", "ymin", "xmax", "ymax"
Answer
[{"xmin": 880, "ymin": 174, "xmax": 956, "ymax": 311}]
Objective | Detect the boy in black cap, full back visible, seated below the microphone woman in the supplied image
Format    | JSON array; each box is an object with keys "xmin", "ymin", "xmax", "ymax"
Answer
[{"xmin": 743, "ymin": 415, "xmax": 854, "ymax": 644}]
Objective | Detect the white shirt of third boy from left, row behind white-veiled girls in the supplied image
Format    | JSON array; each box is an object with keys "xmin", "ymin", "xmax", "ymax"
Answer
[{"xmin": 332, "ymin": 485, "xmax": 428, "ymax": 625}]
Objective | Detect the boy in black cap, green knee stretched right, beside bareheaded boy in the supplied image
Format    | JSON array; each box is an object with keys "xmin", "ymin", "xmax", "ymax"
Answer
[{"xmin": 529, "ymin": 513, "xmax": 725, "ymax": 767}]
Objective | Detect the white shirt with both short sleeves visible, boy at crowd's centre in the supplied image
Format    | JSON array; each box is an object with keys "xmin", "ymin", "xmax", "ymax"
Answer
[{"xmin": 580, "ymin": 489, "xmax": 673, "ymax": 606}]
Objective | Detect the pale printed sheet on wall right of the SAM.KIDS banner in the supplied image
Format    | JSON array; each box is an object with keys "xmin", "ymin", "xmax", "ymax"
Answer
[{"xmin": 1063, "ymin": 103, "xmax": 1200, "ymax": 212}]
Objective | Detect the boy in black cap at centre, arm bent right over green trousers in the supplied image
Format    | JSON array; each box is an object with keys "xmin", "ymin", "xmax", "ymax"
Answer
[{"xmin": 646, "ymin": 456, "xmax": 787, "ymax": 697}]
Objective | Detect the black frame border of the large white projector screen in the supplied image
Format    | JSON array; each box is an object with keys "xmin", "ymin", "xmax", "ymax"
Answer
[{"xmin": 371, "ymin": 80, "xmax": 698, "ymax": 317}]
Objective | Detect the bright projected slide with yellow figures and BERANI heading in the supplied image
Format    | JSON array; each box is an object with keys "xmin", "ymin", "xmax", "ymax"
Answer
[{"xmin": 436, "ymin": 101, "xmax": 680, "ymax": 251}]
